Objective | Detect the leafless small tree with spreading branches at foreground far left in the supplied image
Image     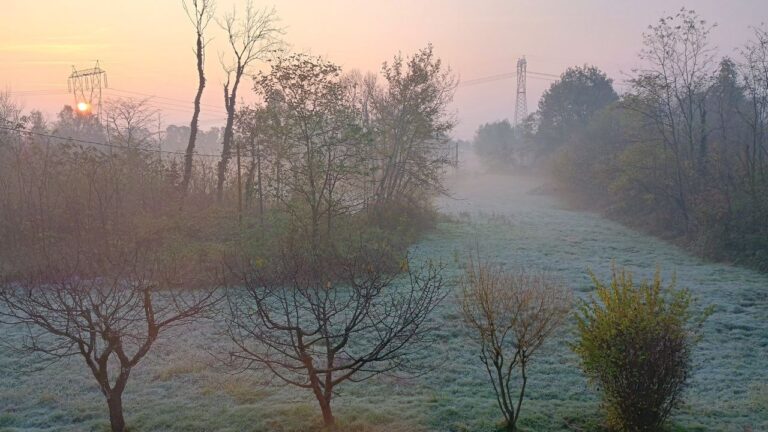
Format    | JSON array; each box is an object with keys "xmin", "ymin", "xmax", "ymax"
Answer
[{"xmin": 0, "ymin": 250, "xmax": 214, "ymax": 432}]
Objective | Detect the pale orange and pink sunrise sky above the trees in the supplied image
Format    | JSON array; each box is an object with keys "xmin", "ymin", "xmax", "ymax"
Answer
[{"xmin": 0, "ymin": 0, "xmax": 768, "ymax": 139}]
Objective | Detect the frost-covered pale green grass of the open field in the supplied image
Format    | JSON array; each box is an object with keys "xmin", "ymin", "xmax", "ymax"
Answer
[{"xmin": 0, "ymin": 171, "xmax": 768, "ymax": 432}]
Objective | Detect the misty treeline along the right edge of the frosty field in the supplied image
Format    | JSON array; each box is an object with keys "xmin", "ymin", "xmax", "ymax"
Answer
[{"xmin": 475, "ymin": 10, "xmax": 768, "ymax": 270}]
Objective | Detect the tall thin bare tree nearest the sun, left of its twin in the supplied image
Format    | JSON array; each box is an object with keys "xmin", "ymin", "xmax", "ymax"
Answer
[{"xmin": 181, "ymin": 0, "xmax": 215, "ymax": 194}]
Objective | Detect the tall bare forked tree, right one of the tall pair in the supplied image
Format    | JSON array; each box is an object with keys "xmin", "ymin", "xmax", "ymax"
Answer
[{"xmin": 217, "ymin": 0, "xmax": 281, "ymax": 200}]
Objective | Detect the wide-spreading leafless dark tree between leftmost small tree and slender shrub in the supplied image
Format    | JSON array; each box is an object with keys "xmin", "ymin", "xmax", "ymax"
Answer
[{"xmin": 227, "ymin": 246, "xmax": 445, "ymax": 429}]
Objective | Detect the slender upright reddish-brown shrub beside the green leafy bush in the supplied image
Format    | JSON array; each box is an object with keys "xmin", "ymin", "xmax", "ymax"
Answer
[{"xmin": 461, "ymin": 258, "xmax": 571, "ymax": 431}]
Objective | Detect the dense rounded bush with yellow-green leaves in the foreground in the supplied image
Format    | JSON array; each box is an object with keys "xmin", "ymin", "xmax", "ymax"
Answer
[{"xmin": 573, "ymin": 268, "xmax": 700, "ymax": 432}]
